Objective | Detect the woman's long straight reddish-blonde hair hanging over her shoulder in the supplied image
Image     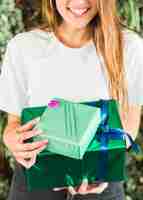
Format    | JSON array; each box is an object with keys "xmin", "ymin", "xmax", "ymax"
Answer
[{"xmin": 41, "ymin": 0, "xmax": 129, "ymax": 118}]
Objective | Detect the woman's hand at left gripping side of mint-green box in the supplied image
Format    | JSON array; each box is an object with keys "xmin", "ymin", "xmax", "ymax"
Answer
[{"xmin": 3, "ymin": 118, "xmax": 48, "ymax": 168}]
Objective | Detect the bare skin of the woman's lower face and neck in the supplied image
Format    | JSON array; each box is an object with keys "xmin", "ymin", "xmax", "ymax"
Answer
[{"xmin": 56, "ymin": 0, "xmax": 97, "ymax": 48}]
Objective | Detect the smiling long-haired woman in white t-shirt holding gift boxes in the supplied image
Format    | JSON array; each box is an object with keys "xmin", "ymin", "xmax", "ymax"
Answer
[{"xmin": 0, "ymin": 0, "xmax": 143, "ymax": 200}]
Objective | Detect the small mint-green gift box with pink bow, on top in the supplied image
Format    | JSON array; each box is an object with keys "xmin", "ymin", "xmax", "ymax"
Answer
[{"xmin": 33, "ymin": 98, "xmax": 101, "ymax": 159}]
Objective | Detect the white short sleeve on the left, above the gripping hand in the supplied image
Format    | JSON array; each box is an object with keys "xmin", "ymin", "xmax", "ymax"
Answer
[{"xmin": 0, "ymin": 36, "xmax": 28, "ymax": 116}]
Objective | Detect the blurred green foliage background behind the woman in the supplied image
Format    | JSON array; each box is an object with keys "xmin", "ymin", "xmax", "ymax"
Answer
[{"xmin": 0, "ymin": 0, "xmax": 143, "ymax": 200}]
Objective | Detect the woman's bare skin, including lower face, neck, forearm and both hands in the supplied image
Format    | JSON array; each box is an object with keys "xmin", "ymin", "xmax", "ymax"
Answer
[{"xmin": 3, "ymin": 0, "xmax": 141, "ymax": 194}]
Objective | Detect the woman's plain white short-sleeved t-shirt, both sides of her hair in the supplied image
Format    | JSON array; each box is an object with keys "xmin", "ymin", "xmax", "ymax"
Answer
[{"xmin": 0, "ymin": 29, "xmax": 143, "ymax": 116}]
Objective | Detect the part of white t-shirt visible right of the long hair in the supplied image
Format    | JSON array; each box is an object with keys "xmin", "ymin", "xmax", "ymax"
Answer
[{"xmin": 124, "ymin": 30, "xmax": 143, "ymax": 105}]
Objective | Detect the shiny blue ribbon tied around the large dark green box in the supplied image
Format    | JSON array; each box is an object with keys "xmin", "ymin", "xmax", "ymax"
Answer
[{"xmin": 82, "ymin": 100, "xmax": 140, "ymax": 181}]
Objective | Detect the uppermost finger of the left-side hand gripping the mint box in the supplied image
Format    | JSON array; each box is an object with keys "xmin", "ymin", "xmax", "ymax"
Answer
[{"xmin": 17, "ymin": 117, "xmax": 40, "ymax": 132}]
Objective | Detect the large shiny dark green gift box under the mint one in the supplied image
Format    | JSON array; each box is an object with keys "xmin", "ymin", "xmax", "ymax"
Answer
[{"xmin": 21, "ymin": 99, "xmax": 126, "ymax": 191}]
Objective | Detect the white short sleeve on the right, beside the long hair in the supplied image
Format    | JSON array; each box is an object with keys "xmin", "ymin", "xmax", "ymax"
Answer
[{"xmin": 127, "ymin": 34, "xmax": 143, "ymax": 106}]
